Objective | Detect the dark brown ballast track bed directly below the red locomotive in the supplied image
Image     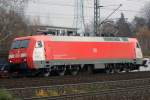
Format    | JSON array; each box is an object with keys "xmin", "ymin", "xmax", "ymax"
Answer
[{"xmin": 0, "ymin": 72, "xmax": 150, "ymax": 89}]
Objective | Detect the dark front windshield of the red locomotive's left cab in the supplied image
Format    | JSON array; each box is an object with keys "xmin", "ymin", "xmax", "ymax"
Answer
[{"xmin": 11, "ymin": 40, "xmax": 29, "ymax": 49}]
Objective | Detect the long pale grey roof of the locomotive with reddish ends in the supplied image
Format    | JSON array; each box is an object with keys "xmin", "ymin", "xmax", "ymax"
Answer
[{"xmin": 15, "ymin": 35, "xmax": 136, "ymax": 42}]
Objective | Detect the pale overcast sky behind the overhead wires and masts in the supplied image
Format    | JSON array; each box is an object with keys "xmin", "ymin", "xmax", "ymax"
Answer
[{"xmin": 26, "ymin": 0, "xmax": 150, "ymax": 27}]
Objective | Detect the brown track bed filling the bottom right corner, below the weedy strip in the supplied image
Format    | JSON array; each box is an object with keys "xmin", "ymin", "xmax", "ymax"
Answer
[{"xmin": 24, "ymin": 85, "xmax": 150, "ymax": 100}]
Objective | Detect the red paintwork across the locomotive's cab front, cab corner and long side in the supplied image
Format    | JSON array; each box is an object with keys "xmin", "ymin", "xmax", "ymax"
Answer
[{"xmin": 9, "ymin": 35, "xmax": 137, "ymax": 69}]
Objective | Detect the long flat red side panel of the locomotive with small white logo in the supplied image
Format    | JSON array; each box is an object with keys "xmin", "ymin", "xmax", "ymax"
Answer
[{"xmin": 45, "ymin": 42, "xmax": 135, "ymax": 60}]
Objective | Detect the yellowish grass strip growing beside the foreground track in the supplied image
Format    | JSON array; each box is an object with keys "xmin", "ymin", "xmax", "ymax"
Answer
[{"xmin": 35, "ymin": 84, "xmax": 112, "ymax": 97}]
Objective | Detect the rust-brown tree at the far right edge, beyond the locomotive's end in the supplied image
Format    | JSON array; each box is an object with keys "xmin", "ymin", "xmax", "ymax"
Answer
[{"xmin": 133, "ymin": 2, "xmax": 150, "ymax": 56}]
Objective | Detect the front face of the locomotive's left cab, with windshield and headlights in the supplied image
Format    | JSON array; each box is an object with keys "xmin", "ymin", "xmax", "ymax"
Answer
[{"xmin": 8, "ymin": 38, "xmax": 31, "ymax": 73}]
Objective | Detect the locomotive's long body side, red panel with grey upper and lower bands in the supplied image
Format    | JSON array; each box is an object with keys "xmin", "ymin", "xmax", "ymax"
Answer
[{"xmin": 45, "ymin": 36, "xmax": 142, "ymax": 69}]
